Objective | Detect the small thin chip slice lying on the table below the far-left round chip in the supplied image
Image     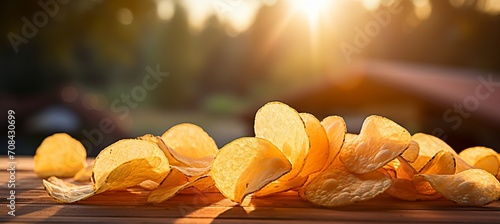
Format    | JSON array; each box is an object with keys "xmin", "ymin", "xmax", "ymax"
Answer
[{"xmin": 43, "ymin": 177, "xmax": 95, "ymax": 203}]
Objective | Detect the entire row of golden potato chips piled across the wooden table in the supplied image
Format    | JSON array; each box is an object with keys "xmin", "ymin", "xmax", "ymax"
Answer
[{"xmin": 35, "ymin": 102, "xmax": 500, "ymax": 207}]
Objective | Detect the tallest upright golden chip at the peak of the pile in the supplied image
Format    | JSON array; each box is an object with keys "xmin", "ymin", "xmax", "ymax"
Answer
[{"xmin": 254, "ymin": 102, "xmax": 310, "ymax": 181}]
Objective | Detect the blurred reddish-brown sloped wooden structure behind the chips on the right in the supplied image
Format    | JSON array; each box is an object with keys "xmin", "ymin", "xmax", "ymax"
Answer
[{"xmin": 245, "ymin": 60, "xmax": 500, "ymax": 151}]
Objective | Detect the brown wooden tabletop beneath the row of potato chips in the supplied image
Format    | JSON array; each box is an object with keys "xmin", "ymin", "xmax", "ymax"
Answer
[{"xmin": 0, "ymin": 156, "xmax": 500, "ymax": 223}]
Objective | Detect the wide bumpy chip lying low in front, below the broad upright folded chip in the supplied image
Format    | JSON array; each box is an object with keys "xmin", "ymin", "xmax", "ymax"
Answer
[{"xmin": 304, "ymin": 162, "xmax": 391, "ymax": 207}]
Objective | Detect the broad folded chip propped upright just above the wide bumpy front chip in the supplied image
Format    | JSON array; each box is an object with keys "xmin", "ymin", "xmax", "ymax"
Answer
[{"xmin": 340, "ymin": 115, "xmax": 411, "ymax": 173}]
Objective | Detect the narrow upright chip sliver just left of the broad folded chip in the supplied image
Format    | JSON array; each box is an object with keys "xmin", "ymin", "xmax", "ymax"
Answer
[{"xmin": 321, "ymin": 116, "xmax": 347, "ymax": 170}]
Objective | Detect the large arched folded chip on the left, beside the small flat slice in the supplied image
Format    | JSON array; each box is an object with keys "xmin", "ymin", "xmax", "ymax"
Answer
[{"xmin": 92, "ymin": 139, "xmax": 170, "ymax": 193}]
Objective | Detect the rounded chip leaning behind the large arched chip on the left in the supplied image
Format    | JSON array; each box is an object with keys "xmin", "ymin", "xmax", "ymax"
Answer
[{"xmin": 161, "ymin": 123, "xmax": 218, "ymax": 167}]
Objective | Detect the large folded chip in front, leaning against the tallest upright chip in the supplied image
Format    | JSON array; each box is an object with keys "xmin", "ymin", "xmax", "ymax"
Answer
[{"xmin": 210, "ymin": 137, "xmax": 292, "ymax": 203}]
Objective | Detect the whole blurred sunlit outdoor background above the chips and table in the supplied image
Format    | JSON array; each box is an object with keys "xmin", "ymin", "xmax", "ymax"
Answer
[{"xmin": 0, "ymin": 0, "xmax": 500, "ymax": 156}]
